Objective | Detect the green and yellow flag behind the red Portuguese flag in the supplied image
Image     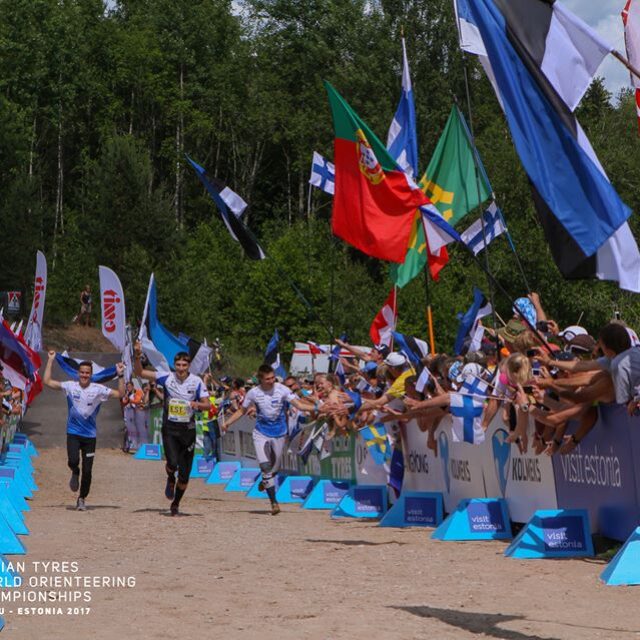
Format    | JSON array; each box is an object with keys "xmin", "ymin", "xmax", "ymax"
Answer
[{"xmin": 390, "ymin": 105, "xmax": 491, "ymax": 287}]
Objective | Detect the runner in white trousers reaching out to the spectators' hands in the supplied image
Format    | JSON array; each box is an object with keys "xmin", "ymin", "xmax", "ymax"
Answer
[{"xmin": 224, "ymin": 364, "xmax": 318, "ymax": 516}]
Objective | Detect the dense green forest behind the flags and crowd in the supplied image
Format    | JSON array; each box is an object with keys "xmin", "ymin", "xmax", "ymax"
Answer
[{"xmin": 0, "ymin": 0, "xmax": 640, "ymax": 353}]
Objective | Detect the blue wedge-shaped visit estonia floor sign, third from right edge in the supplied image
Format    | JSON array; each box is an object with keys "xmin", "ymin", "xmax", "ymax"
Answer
[{"xmin": 431, "ymin": 498, "xmax": 511, "ymax": 540}]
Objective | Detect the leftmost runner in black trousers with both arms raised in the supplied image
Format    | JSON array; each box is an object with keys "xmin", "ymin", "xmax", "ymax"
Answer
[{"xmin": 43, "ymin": 351, "xmax": 125, "ymax": 511}]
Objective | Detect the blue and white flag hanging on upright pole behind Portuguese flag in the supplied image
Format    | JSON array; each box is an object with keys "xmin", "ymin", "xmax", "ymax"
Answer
[{"xmin": 387, "ymin": 38, "xmax": 418, "ymax": 178}]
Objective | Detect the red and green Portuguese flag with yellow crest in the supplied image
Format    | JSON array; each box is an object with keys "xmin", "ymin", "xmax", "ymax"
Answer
[{"xmin": 325, "ymin": 82, "xmax": 429, "ymax": 262}]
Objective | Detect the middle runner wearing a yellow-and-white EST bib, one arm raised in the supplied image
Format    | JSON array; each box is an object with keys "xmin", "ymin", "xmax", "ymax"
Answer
[{"xmin": 133, "ymin": 342, "xmax": 210, "ymax": 516}]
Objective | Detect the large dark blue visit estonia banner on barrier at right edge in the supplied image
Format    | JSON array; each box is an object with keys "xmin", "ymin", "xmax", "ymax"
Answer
[{"xmin": 553, "ymin": 404, "xmax": 640, "ymax": 541}]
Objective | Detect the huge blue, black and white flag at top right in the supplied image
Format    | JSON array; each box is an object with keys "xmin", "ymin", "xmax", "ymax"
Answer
[{"xmin": 456, "ymin": 0, "xmax": 640, "ymax": 292}]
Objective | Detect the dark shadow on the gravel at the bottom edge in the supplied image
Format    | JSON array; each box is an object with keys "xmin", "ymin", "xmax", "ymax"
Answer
[{"xmin": 390, "ymin": 606, "xmax": 557, "ymax": 640}]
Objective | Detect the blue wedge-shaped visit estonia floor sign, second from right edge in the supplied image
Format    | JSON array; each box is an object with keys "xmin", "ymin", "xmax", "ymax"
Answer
[{"xmin": 504, "ymin": 509, "xmax": 594, "ymax": 559}]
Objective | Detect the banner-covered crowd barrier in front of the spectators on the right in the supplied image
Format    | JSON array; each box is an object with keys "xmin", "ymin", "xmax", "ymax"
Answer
[{"xmin": 220, "ymin": 405, "xmax": 640, "ymax": 541}]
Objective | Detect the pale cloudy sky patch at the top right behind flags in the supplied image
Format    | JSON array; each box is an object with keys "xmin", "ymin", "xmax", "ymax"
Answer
[{"xmin": 562, "ymin": 0, "xmax": 630, "ymax": 95}]
